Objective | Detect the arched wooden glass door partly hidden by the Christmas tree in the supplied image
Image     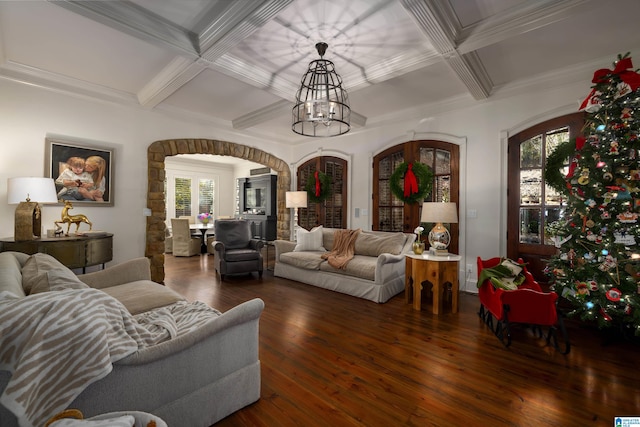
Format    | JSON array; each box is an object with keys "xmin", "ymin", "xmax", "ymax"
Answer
[{"xmin": 507, "ymin": 113, "xmax": 584, "ymax": 283}]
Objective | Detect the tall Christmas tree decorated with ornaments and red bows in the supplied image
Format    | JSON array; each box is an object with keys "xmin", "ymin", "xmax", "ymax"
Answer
[{"xmin": 545, "ymin": 54, "xmax": 640, "ymax": 335}]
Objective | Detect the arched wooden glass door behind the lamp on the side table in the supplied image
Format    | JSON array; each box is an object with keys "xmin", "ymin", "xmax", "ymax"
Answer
[{"xmin": 372, "ymin": 140, "xmax": 460, "ymax": 253}]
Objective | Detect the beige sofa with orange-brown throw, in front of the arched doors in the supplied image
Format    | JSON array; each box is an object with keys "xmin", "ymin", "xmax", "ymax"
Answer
[{"xmin": 274, "ymin": 228, "xmax": 415, "ymax": 303}]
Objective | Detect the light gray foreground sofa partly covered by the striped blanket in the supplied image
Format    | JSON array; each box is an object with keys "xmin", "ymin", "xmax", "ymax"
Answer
[{"xmin": 0, "ymin": 252, "xmax": 264, "ymax": 427}]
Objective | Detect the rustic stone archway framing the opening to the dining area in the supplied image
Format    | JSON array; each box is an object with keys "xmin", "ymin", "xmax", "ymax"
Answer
[{"xmin": 145, "ymin": 139, "xmax": 291, "ymax": 283}]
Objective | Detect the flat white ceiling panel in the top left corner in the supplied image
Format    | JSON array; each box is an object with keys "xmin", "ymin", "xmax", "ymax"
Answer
[{"xmin": 0, "ymin": 1, "xmax": 174, "ymax": 94}]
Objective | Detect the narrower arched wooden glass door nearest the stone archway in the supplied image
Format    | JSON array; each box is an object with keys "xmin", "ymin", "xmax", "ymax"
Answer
[{"xmin": 297, "ymin": 156, "xmax": 348, "ymax": 230}]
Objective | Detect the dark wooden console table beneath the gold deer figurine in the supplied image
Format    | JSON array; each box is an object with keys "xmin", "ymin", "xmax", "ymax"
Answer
[{"xmin": 0, "ymin": 233, "xmax": 113, "ymax": 272}]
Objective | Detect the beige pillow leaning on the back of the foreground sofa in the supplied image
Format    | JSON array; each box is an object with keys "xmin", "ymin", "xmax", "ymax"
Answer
[{"xmin": 22, "ymin": 253, "xmax": 86, "ymax": 295}]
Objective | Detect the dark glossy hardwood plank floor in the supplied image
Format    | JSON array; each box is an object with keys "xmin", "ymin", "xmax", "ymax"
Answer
[{"xmin": 165, "ymin": 255, "xmax": 640, "ymax": 427}]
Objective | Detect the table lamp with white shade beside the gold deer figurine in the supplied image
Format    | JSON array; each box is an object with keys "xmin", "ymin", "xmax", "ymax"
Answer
[{"xmin": 7, "ymin": 177, "xmax": 58, "ymax": 242}]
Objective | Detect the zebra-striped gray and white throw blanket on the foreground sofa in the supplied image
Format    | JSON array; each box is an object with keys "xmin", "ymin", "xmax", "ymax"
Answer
[{"xmin": 0, "ymin": 289, "xmax": 220, "ymax": 427}]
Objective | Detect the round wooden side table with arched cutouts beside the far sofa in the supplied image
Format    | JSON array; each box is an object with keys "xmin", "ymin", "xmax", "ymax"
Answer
[{"xmin": 404, "ymin": 252, "xmax": 462, "ymax": 314}]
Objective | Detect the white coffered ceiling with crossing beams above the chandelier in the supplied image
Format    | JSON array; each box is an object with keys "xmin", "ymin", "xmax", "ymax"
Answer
[{"xmin": 0, "ymin": 0, "xmax": 640, "ymax": 144}]
